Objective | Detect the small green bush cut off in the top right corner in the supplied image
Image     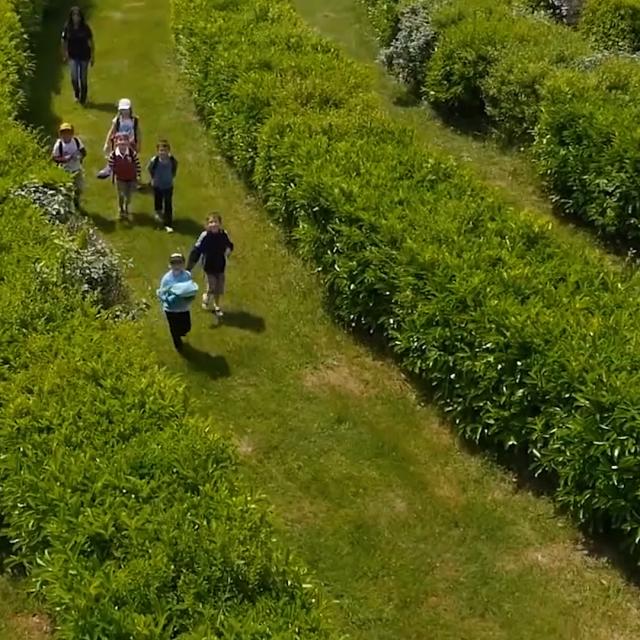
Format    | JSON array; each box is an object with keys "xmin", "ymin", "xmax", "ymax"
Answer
[{"xmin": 580, "ymin": 0, "xmax": 640, "ymax": 51}]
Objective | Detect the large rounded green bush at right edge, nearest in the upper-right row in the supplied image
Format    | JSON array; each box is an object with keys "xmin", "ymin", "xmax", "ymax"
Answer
[{"xmin": 534, "ymin": 58, "xmax": 640, "ymax": 241}]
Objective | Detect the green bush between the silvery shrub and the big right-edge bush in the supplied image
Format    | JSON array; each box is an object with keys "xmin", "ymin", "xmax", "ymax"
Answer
[{"xmin": 425, "ymin": 0, "xmax": 588, "ymax": 140}]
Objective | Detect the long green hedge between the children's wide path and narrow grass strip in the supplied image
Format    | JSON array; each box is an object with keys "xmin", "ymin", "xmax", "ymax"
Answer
[{"xmin": 172, "ymin": 0, "xmax": 640, "ymax": 547}]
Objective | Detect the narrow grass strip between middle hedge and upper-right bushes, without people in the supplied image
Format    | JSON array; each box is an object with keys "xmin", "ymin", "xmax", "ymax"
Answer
[{"xmin": 292, "ymin": 0, "xmax": 619, "ymax": 264}]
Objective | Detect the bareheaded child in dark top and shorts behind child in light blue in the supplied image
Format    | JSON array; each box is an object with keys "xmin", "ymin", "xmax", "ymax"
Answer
[{"xmin": 187, "ymin": 213, "xmax": 233, "ymax": 318}]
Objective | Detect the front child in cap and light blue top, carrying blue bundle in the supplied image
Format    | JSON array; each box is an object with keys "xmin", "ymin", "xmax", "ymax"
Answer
[{"xmin": 157, "ymin": 253, "xmax": 198, "ymax": 353}]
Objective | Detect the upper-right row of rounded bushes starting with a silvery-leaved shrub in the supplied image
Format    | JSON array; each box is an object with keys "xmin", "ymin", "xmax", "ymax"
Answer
[{"xmin": 382, "ymin": 0, "xmax": 640, "ymax": 244}]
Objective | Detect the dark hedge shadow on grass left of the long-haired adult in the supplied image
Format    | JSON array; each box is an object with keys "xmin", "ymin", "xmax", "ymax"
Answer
[{"xmin": 23, "ymin": 0, "xmax": 96, "ymax": 137}]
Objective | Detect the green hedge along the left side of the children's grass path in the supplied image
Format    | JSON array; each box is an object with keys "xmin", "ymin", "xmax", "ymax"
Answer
[{"xmin": 0, "ymin": 0, "xmax": 335, "ymax": 640}]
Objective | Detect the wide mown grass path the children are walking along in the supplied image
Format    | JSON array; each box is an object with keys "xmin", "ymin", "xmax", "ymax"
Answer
[{"xmin": 12, "ymin": 0, "xmax": 640, "ymax": 640}]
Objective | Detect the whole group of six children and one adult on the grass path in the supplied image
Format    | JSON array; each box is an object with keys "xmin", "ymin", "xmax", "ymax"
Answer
[{"xmin": 52, "ymin": 7, "xmax": 234, "ymax": 352}]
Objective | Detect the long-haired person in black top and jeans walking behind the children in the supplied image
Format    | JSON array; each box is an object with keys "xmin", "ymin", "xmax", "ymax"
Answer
[{"xmin": 62, "ymin": 7, "xmax": 94, "ymax": 104}]
